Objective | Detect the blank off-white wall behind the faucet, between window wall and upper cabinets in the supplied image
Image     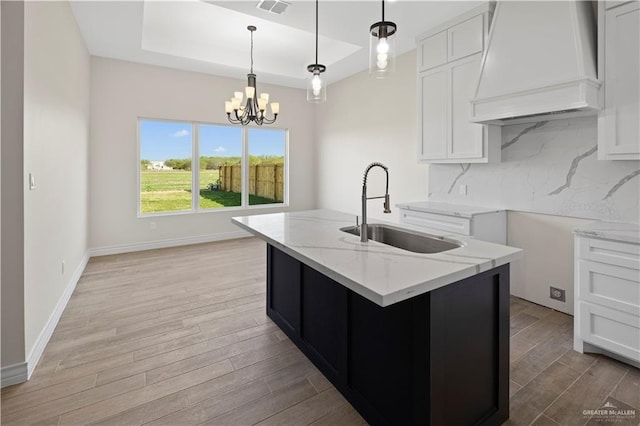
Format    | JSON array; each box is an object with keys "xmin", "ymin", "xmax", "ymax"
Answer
[{"xmin": 317, "ymin": 50, "xmax": 427, "ymax": 221}]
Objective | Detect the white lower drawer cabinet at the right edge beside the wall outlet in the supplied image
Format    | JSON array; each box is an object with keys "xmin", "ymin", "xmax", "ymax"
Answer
[{"xmin": 574, "ymin": 224, "xmax": 640, "ymax": 366}]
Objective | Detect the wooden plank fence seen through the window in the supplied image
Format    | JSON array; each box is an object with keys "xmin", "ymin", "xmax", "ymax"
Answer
[{"xmin": 220, "ymin": 163, "xmax": 284, "ymax": 202}]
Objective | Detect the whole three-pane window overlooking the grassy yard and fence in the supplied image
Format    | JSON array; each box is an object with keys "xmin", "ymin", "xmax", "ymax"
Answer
[{"xmin": 138, "ymin": 119, "xmax": 287, "ymax": 215}]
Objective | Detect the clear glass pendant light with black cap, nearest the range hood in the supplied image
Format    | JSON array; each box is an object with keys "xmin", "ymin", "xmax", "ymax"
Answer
[{"xmin": 369, "ymin": 0, "xmax": 397, "ymax": 78}]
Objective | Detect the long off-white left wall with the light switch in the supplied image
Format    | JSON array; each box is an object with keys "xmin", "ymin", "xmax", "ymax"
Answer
[{"xmin": 24, "ymin": 2, "xmax": 90, "ymax": 370}]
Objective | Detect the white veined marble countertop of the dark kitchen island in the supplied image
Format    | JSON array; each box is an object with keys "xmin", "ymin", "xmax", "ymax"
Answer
[{"xmin": 232, "ymin": 210, "xmax": 522, "ymax": 306}]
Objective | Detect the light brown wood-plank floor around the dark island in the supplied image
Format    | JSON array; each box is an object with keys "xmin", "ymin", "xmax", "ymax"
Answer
[{"xmin": 1, "ymin": 239, "xmax": 640, "ymax": 426}]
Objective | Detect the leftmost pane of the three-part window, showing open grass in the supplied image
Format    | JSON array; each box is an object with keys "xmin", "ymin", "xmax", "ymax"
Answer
[{"xmin": 140, "ymin": 120, "xmax": 192, "ymax": 213}]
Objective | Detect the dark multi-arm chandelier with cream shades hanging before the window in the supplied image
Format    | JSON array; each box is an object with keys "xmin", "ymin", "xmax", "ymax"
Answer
[{"xmin": 224, "ymin": 25, "xmax": 280, "ymax": 126}]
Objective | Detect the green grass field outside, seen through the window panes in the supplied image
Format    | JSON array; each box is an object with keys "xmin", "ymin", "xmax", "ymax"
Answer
[{"xmin": 140, "ymin": 170, "xmax": 276, "ymax": 213}]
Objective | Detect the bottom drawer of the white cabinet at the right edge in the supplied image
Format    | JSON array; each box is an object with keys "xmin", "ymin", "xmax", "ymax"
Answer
[{"xmin": 579, "ymin": 302, "xmax": 640, "ymax": 362}]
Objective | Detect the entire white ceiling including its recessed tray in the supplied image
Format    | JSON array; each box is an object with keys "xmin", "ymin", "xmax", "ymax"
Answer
[{"xmin": 69, "ymin": 0, "xmax": 482, "ymax": 89}]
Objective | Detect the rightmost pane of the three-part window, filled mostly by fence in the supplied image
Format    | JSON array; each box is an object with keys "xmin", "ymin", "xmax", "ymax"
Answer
[{"xmin": 249, "ymin": 129, "xmax": 286, "ymax": 205}]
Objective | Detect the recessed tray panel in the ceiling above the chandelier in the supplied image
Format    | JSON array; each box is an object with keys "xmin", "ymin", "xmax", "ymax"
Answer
[{"xmin": 142, "ymin": 1, "xmax": 362, "ymax": 78}]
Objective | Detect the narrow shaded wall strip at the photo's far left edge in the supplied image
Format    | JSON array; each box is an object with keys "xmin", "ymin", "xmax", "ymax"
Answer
[{"xmin": 0, "ymin": 1, "xmax": 26, "ymax": 380}]
